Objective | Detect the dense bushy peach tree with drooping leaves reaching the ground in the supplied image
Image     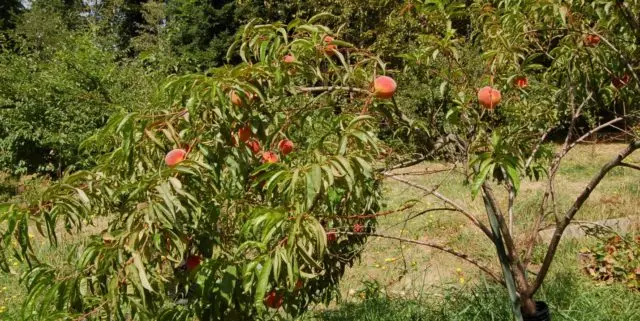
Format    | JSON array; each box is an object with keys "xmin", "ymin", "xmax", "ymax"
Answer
[{"xmin": 0, "ymin": 16, "xmax": 395, "ymax": 320}]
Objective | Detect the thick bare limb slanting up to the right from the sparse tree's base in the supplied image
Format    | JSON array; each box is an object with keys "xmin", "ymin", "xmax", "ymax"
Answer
[{"xmin": 528, "ymin": 140, "xmax": 640, "ymax": 295}]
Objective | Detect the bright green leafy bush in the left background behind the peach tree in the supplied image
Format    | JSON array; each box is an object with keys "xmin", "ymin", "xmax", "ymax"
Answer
[{"xmin": 0, "ymin": 9, "xmax": 160, "ymax": 174}]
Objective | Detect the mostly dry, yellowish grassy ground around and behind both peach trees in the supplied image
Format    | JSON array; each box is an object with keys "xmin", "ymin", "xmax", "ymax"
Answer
[{"xmin": 0, "ymin": 144, "xmax": 640, "ymax": 321}]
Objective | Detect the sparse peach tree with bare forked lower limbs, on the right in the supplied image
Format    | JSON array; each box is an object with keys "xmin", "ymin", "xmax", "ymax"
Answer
[{"xmin": 377, "ymin": 0, "xmax": 640, "ymax": 320}]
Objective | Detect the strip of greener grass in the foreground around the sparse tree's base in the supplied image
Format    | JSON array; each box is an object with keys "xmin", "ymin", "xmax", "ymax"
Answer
[{"xmin": 314, "ymin": 272, "xmax": 640, "ymax": 321}]
